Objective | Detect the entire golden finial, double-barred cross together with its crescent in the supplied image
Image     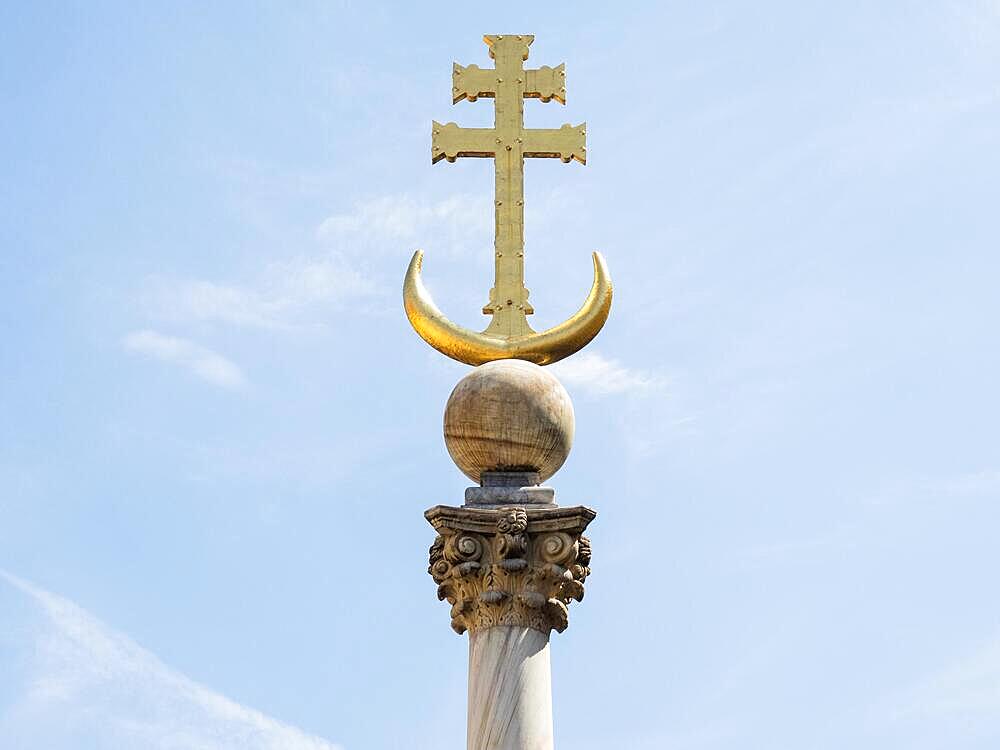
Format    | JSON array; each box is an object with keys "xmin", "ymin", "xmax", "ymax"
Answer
[{"xmin": 403, "ymin": 35, "xmax": 612, "ymax": 365}]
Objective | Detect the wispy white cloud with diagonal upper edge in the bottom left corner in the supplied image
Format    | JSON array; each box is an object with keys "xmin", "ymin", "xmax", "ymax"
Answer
[{"xmin": 0, "ymin": 571, "xmax": 338, "ymax": 750}]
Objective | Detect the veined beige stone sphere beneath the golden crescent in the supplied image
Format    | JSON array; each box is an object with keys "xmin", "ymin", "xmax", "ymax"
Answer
[{"xmin": 444, "ymin": 359, "xmax": 575, "ymax": 483}]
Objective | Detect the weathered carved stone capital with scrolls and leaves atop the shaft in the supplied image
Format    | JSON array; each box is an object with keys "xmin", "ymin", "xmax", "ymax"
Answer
[{"xmin": 425, "ymin": 505, "xmax": 596, "ymax": 634}]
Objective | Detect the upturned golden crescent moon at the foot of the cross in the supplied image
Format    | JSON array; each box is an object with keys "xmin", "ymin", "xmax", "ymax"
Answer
[{"xmin": 403, "ymin": 250, "xmax": 612, "ymax": 366}]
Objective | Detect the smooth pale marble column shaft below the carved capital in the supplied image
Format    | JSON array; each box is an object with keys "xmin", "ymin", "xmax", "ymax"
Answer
[{"xmin": 468, "ymin": 625, "xmax": 553, "ymax": 750}]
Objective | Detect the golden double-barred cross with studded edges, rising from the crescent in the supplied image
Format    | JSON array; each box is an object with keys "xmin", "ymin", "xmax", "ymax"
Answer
[{"xmin": 431, "ymin": 34, "xmax": 587, "ymax": 339}]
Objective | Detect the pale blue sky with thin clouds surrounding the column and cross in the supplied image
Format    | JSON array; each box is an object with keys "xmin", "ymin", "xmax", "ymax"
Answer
[{"xmin": 0, "ymin": 0, "xmax": 1000, "ymax": 750}]
